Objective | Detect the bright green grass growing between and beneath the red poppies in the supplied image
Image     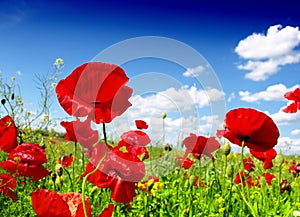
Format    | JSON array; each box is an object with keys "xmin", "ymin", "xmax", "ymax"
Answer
[{"xmin": 0, "ymin": 138, "xmax": 300, "ymax": 217}]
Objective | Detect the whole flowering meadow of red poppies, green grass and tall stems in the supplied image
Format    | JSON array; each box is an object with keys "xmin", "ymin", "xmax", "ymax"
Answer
[{"xmin": 0, "ymin": 60, "xmax": 300, "ymax": 217}]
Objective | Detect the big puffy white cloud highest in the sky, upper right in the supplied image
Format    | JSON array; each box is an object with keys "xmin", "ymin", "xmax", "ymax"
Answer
[{"xmin": 235, "ymin": 25, "xmax": 300, "ymax": 81}]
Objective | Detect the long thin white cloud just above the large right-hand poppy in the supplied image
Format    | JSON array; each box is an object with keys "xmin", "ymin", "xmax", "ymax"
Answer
[{"xmin": 239, "ymin": 84, "xmax": 299, "ymax": 102}]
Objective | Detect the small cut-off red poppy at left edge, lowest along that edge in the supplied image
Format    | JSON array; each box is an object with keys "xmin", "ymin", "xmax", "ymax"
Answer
[{"xmin": 0, "ymin": 174, "xmax": 18, "ymax": 202}]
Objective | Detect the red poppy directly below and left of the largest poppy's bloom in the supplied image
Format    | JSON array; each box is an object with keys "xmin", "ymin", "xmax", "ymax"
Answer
[{"xmin": 60, "ymin": 119, "xmax": 99, "ymax": 149}]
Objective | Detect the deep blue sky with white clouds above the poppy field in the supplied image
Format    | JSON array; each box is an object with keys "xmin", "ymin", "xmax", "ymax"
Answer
[{"xmin": 0, "ymin": 0, "xmax": 300, "ymax": 153}]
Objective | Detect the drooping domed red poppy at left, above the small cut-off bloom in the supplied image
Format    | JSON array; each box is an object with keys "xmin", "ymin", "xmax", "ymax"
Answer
[{"xmin": 0, "ymin": 143, "xmax": 50, "ymax": 181}]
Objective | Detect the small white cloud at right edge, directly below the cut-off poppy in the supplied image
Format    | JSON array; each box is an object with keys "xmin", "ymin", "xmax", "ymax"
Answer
[{"xmin": 270, "ymin": 108, "xmax": 300, "ymax": 126}]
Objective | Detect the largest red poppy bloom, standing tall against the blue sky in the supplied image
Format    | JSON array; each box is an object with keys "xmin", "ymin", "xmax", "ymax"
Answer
[{"xmin": 56, "ymin": 62, "xmax": 132, "ymax": 123}]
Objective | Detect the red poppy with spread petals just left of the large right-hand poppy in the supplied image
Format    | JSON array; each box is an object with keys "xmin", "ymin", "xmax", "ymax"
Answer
[{"xmin": 183, "ymin": 133, "xmax": 220, "ymax": 159}]
